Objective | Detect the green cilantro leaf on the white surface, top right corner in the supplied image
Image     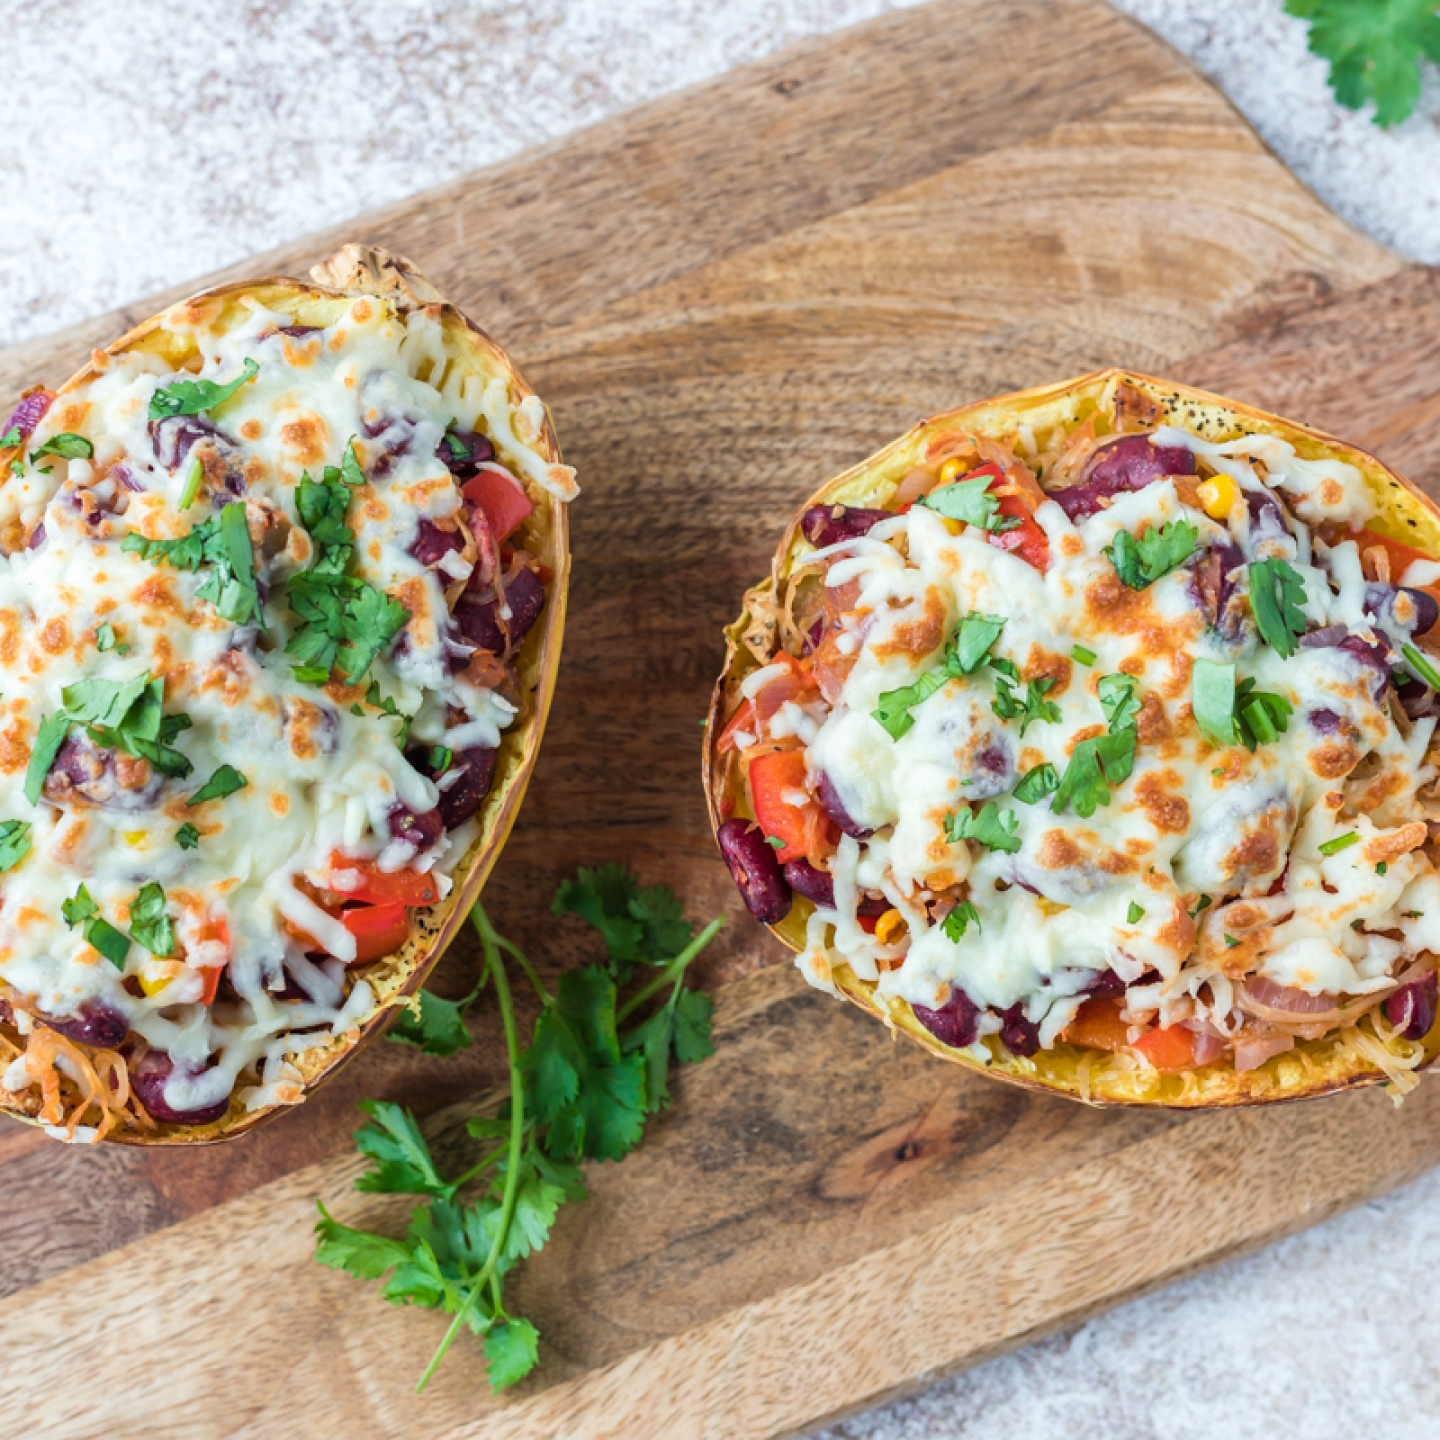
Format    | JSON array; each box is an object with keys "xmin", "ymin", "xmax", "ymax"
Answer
[{"xmin": 1284, "ymin": 0, "xmax": 1440, "ymax": 130}]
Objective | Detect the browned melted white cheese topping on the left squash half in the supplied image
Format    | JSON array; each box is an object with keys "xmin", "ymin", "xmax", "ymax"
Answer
[{"xmin": 0, "ymin": 298, "xmax": 573, "ymax": 1110}]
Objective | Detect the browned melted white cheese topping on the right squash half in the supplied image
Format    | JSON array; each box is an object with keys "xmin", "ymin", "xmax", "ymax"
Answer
[{"xmin": 789, "ymin": 429, "xmax": 1440, "ymax": 1058}]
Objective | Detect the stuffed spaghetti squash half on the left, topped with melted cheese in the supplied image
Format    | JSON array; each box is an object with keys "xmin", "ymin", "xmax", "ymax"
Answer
[{"xmin": 0, "ymin": 245, "xmax": 576, "ymax": 1143}]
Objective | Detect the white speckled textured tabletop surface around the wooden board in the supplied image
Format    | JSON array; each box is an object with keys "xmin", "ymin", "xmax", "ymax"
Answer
[{"xmin": 0, "ymin": 0, "xmax": 1440, "ymax": 1440}]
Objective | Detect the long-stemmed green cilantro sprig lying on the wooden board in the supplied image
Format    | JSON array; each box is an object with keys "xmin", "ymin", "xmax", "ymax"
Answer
[{"xmin": 315, "ymin": 865, "xmax": 720, "ymax": 1391}]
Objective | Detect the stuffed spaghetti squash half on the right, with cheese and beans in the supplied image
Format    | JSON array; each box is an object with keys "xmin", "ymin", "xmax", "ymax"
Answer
[{"xmin": 706, "ymin": 372, "xmax": 1440, "ymax": 1107}]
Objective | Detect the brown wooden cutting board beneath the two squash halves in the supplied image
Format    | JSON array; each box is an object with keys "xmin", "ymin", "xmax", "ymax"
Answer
[{"xmin": 0, "ymin": 0, "xmax": 1440, "ymax": 1440}]
